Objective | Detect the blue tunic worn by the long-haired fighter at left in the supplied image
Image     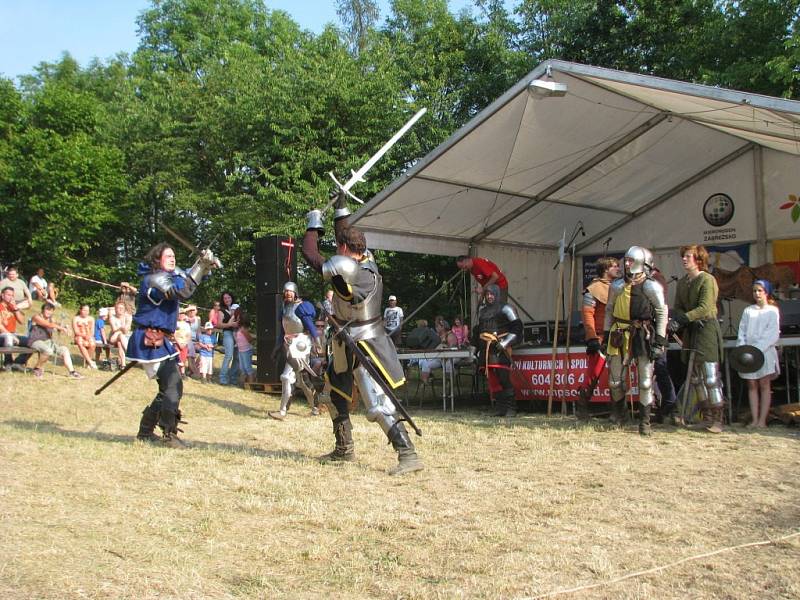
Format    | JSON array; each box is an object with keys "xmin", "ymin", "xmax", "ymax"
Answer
[{"xmin": 126, "ymin": 264, "xmax": 191, "ymax": 363}]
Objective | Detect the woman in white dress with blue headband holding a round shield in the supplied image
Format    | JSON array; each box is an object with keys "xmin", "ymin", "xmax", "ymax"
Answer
[{"xmin": 736, "ymin": 279, "xmax": 781, "ymax": 427}]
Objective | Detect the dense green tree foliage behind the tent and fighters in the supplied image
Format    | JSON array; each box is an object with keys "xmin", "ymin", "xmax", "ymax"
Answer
[{"xmin": 0, "ymin": 0, "xmax": 800, "ymax": 316}]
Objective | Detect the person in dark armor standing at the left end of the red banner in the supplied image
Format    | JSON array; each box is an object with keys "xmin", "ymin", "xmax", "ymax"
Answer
[{"xmin": 473, "ymin": 284, "xmax": 522, "ymax": 417}]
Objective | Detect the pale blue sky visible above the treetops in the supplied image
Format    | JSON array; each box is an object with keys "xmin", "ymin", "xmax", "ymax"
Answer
[{"xmin": 0, "ymin": 0, "xmax": 482, "ymax": 78}]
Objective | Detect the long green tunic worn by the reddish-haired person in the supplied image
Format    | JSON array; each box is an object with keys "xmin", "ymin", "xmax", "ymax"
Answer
[{"xmin": 674, "ymin": 271, "xmax": 723, "ymax": 362}]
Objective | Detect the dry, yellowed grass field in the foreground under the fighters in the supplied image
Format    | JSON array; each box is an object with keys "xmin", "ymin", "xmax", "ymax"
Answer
[{"xmin": 0, "ymin": 366, "xmax": 800, "ymax": 599}]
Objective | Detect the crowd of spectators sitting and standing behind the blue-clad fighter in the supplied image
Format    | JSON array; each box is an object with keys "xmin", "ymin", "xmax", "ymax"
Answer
[{"xmin": 0, "ymin": 266, "xmax": 255, "ymax": 384}]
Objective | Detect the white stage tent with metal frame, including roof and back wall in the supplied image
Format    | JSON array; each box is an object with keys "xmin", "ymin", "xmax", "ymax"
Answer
[{"xmin": 353, "ymin": 61, "xmax": 800, "ymax": 318}]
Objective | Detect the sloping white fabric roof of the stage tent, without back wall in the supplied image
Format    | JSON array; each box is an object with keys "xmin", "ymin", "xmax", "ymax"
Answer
[{"xmin": 353, "ymin": 61, "xmax": 800, "ymax": 254}]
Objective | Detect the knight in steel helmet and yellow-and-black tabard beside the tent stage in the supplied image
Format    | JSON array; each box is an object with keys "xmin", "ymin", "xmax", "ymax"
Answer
[{"xmin": 603, "ymin": 246, "xmax": 667, "ymax": 435}]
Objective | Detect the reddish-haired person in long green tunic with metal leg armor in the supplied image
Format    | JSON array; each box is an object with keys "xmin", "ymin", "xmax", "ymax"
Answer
[{"xmin": 670, "ymin": 245, "xmax": 725, "ymax": 433}]
